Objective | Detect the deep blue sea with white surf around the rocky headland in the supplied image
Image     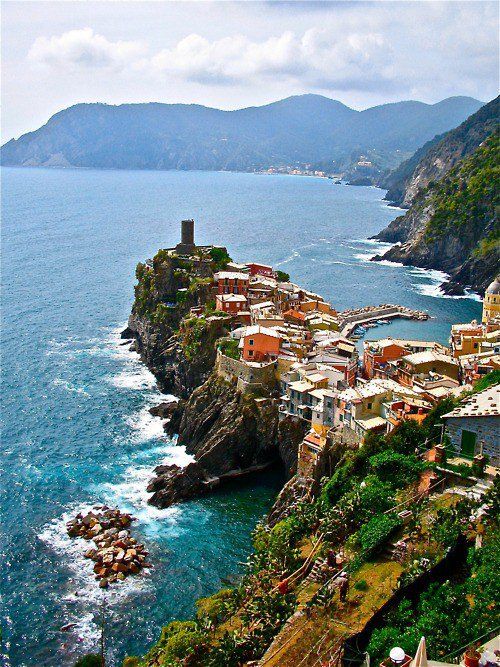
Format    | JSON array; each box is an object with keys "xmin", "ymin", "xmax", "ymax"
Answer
[{"xmin": 0, "ymin": 168, "xmax": 480, "ymax": 667}]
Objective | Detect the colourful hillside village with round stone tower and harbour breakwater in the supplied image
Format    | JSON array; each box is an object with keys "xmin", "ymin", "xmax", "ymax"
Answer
[{"xmin": 163, "ymin": 220, "xmax": 500, "ymax": 476}]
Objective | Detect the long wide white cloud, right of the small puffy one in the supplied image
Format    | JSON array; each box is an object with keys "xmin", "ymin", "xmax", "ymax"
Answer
[{"xmin": 146, "ymin": 28, "xmax": 390, "ymax": 90}]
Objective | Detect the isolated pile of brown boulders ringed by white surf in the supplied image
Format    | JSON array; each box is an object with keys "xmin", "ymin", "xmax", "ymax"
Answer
[{"xmin": 66, "ymin": 505, "xmax": 152, "ymax": 588}]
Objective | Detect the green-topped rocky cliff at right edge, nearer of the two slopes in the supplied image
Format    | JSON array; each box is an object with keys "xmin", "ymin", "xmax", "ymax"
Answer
[{"xmin": 374, "ymin": 134, "xmax": 500, "ymax": 294}]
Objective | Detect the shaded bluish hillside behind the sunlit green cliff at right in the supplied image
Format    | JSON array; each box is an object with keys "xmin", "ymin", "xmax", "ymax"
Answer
[{"xmin": 379, "ymin": 97, "xmax": 500, "ymax": 207}]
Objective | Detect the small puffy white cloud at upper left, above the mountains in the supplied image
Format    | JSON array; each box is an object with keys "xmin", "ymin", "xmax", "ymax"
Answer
[{"xmin": 28, "ymin": 28, "xmax": 144, "ymax": 70}]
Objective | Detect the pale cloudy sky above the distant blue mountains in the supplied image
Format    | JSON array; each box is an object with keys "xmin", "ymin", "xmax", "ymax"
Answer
[{"xmin": 1, "ymin": 0, "xmax": 498, "ymax": 141}]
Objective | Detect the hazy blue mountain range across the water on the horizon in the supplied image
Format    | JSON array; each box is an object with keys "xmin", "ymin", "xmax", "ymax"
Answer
[{"xmin": 1, "ymin": 95, "xmax": 481, "ymax": 171}]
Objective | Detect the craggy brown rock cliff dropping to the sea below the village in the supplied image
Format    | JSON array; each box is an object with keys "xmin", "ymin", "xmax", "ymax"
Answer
[{"xmin": 122, "ymin": 245, "xmax": 304, "ymax": 507}]
